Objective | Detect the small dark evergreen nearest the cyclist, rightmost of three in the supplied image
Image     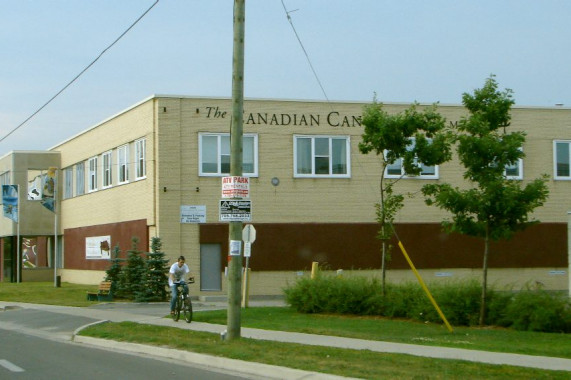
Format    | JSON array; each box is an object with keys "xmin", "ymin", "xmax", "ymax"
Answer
[{"xmin": 135, "ymin": 237, "xmax": 169, "ymax": 302}]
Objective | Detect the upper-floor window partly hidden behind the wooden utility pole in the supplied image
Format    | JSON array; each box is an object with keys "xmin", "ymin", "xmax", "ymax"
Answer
[{"xmin": 198, "ymin": 133, "xmax": 258, "ymax": 177}]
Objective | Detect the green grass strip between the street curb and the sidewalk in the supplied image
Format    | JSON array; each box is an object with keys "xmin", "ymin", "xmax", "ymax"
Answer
[{"xmin": 81, "ymin": 320, "xmax": 569, "ymax": 380}]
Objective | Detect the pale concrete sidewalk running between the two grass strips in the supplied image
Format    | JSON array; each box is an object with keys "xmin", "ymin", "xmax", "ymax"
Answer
[{"xmin": 0, "ymin": 302, "xmax": 571, "ymax": 379}]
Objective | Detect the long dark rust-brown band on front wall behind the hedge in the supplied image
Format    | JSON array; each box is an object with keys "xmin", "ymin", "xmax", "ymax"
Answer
[{"xmin": 200, "ymin": 223, "xmax": 567, "ymax": 271}]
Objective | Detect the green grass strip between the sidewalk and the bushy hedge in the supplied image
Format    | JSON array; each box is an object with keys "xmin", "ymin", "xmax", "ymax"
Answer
[{"xmin": 193, "ymin": 307, "xmax": 571, "ymax": 359}]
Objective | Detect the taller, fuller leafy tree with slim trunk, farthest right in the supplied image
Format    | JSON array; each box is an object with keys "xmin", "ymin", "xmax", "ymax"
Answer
[{"xmin": 422, "ymin": 76, "xmax": 548, "ymax": 325}]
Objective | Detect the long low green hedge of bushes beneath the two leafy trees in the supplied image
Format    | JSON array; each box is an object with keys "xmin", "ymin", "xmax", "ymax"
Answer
[{"xmin": 284, "ymin": 273, "xmax": 571, "ymax": 332}]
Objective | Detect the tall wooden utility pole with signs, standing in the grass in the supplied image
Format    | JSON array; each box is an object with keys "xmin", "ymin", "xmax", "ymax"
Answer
[{"xmin": 226, "ymin": 0, "xmax": 246, "ymax": 340}]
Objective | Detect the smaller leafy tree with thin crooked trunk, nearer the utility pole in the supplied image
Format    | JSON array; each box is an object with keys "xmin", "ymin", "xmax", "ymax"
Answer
[{"xmin": 359, "ymin": 97, "xmax": 452, "ymax": 294}]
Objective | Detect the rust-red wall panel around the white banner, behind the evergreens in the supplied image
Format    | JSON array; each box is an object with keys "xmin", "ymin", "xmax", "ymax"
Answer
[{"xmin": 64, "ymin": 219, "xmax": 149, "ymax": 270}]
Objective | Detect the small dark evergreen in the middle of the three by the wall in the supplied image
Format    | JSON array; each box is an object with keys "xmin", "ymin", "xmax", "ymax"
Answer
[{"xmin": 119, "ymin": 236, "xmax": 147, "ymax": 299}]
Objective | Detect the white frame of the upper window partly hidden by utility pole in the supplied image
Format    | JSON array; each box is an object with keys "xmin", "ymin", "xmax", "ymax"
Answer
[{"xmin": 198, "ymin": 133, "xmax": 258, "ymax": 177}]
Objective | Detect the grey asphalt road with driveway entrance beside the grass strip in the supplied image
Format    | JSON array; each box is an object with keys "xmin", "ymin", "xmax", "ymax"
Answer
[{"xmin": 0, "ymin": 305, "xmax": 260, "ymax": 380}]
